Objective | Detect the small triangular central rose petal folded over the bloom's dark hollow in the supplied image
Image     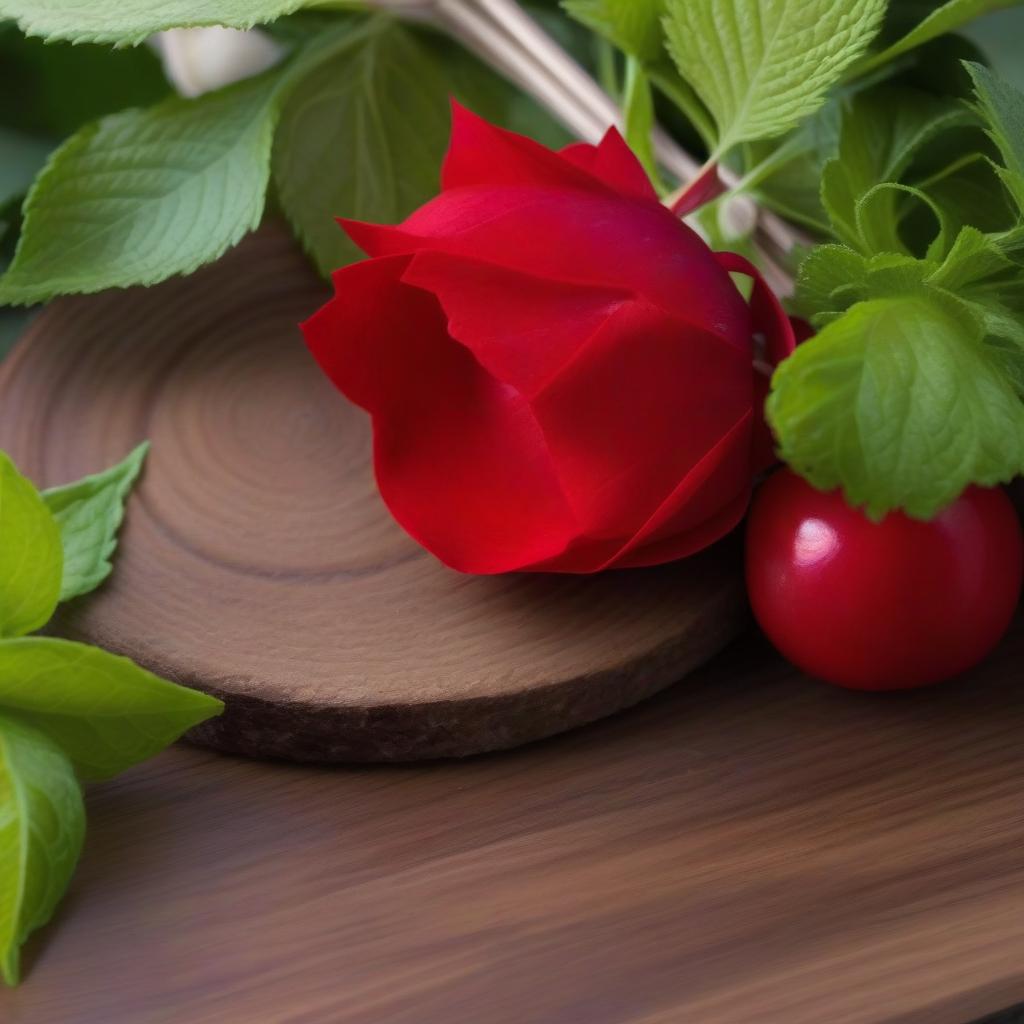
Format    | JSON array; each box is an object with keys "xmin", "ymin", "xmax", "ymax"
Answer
[{"xmin": 402, "ymin": 252, "xmax": 630, "ymax": 398}]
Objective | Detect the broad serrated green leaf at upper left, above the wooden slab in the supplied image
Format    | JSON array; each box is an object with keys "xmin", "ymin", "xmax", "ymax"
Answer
[{"xmin": 0, "ymin": 73, "xmax": 278, "ymax": 304}]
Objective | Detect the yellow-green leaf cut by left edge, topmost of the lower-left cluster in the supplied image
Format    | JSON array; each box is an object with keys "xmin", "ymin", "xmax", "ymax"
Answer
[{"xmin": 0, "ymin": 452, "xmax": 61, "ymax": 637}]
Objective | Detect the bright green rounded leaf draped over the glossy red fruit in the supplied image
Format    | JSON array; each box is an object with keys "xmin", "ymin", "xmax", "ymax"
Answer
[{"xmin": 767, "ymin": 289, "xmax": 1024, "ymax": 519}]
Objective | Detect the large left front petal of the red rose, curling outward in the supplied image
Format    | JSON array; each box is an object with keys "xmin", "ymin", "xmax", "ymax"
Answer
[{"xmin": 302, "ymin": 257, "xmax": 579, "ymax": 573}]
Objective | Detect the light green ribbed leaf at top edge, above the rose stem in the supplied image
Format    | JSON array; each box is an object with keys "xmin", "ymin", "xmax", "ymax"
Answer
[{"xmin": 665, "ymin": 0, "xmax": 885, "ymax": 156}]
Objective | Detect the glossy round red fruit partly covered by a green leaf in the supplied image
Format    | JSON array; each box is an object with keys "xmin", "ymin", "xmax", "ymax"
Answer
[{"xmin": 746, "ymin": 470, "xmax": 1024, "ymax": 690}]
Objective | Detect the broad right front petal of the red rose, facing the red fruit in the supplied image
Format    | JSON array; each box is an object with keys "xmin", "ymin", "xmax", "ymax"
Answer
[{"xmin": 531, "ymin": 302, "xmax": 752, "ymax": 539}]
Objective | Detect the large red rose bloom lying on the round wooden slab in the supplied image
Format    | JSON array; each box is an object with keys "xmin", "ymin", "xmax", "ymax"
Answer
[{"xmin": 303, "ymin": 106, "xmax": 793, "ymax": 572}]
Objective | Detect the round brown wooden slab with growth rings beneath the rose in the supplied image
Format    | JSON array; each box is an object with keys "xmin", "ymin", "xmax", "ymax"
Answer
[{"xmin": 0, "ymin": 225, "xmax": 744, "ymax": 761}]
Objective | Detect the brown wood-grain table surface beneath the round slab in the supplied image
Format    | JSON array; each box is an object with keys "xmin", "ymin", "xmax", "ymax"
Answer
[{"xmin": 0, "ymin": 622, "xmax": 1024, "ymax": 1024}]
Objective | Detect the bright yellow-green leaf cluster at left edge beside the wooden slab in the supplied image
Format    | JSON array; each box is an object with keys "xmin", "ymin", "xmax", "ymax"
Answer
[{"xmin": 0, "ymin": 444, "xmax": 222, "ymax": 985}]
